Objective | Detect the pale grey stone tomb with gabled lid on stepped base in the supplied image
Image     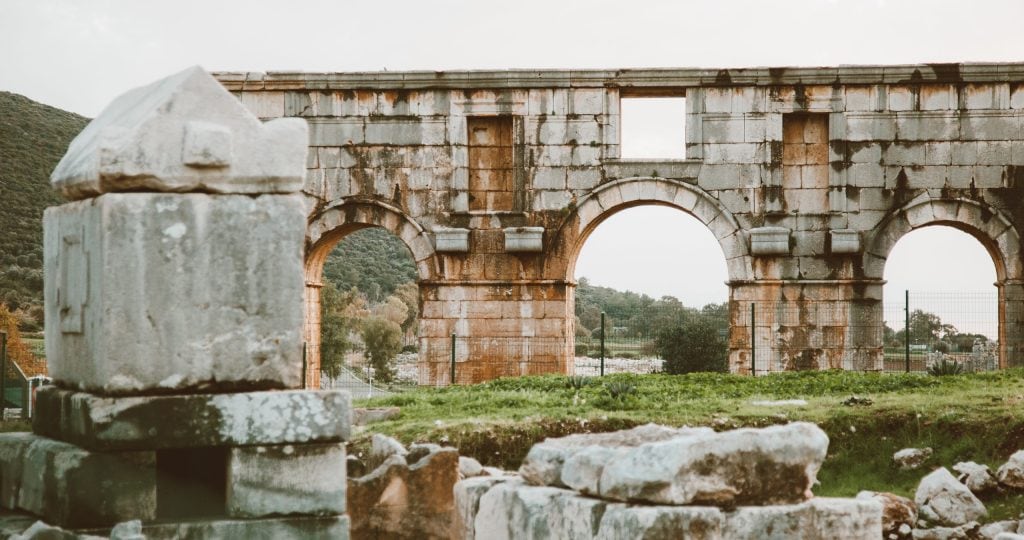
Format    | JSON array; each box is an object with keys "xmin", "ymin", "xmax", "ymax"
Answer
[{"xmin": 0, "ymin": 68, "xmax": 350, "ymax": 538}]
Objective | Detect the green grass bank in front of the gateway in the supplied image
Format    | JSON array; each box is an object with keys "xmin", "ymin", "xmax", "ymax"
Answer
[{"xmin": 353, "ymin": 369, "xmax": 1024, "ymax": 521}]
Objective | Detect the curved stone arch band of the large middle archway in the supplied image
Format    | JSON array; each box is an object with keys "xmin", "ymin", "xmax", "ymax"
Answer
[{"xmin": 546, "ymin": 176, "xmax": 753, "ymax": 282}]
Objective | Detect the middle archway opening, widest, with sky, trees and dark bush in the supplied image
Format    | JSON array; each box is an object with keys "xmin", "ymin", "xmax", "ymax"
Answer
[{"xmin": 572, "ymin": 204, "xmax": 729, "ymax": 375}]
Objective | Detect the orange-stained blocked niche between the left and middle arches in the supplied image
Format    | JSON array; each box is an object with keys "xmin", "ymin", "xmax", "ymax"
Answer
[{"xmin": 466, "ymin": 116, "xmax": 515, "ymax": 212}]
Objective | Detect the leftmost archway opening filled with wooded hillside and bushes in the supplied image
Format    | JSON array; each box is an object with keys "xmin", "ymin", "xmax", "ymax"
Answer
[{"xmin": 307, "ymin": 226, "xmax": 420, "ymax": 398}]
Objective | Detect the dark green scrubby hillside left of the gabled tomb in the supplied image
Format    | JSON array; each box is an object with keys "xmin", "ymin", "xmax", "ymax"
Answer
[{"xmin": 0, "ymin": 92, "xmax": 89, "ymax": 323}]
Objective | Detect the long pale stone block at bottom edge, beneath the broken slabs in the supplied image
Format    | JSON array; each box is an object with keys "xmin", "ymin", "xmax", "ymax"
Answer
[{"xmin": 471, "ymin": 479, "xmax": 882, "ymax": 540}]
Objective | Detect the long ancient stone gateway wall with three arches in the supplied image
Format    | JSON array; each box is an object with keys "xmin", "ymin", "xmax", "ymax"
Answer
[{"xmin": 217, "ymin": 64, "xmax": 1024, "ymax": 384}]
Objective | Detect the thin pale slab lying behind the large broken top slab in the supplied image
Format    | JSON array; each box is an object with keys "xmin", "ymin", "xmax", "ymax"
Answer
[{"xmin": 519, "ymin": 423, "xmax": 714, "ymax": 487}]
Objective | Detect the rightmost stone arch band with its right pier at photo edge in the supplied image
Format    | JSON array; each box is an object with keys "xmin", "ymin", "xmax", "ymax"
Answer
[{"xmin": 863, "ymin": 194, "xmax": 1024, "ymax": 368}]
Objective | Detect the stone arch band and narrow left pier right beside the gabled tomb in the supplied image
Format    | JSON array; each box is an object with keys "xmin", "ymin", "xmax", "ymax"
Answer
[{"xmin": 303, "ymin": 201, "xmax": 439, "ymax": 388}]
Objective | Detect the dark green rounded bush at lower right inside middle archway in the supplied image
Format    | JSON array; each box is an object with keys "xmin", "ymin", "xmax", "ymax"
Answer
[{"xmin": 654, "ymin": 317, "xmax": 728, "ymax": 374}]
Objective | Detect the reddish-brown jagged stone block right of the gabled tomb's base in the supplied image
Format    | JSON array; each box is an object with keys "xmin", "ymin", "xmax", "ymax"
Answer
[{"xmin": 346, "ymin": 445, "xmax": 459, "ymax": 539}]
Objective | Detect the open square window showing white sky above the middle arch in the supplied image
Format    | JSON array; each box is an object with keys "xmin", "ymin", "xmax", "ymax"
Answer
[{"xmin": 620, "ymin": 96, "xmax": 686, "ymax": 160}]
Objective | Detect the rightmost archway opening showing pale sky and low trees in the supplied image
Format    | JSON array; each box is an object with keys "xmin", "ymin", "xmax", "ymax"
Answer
[{"xmin": 883, "ymin": 224, "xmax": 1002, "ymax": 371}]
